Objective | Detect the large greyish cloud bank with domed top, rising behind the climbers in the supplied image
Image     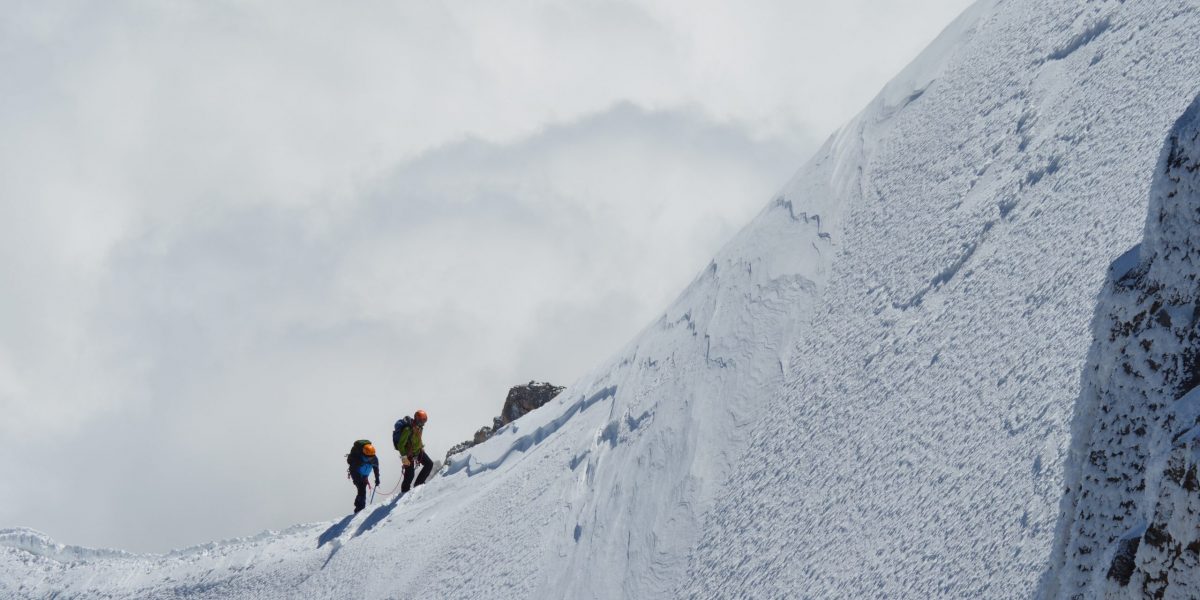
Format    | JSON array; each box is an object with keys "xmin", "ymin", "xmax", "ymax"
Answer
[{"xmin": 5, "ymin": 104, "xmax": 812, "ymax": 548}]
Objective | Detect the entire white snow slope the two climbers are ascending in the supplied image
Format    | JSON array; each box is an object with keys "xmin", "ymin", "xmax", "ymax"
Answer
[{"xmin": 7, "ymin": 0, "xmax": 1200, "ymax": 598}]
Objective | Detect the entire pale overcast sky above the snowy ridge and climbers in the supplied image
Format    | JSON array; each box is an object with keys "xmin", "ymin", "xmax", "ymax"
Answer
[{"xmin": 0, "ymin": 0, "xmax": 971, "ymax": 551}]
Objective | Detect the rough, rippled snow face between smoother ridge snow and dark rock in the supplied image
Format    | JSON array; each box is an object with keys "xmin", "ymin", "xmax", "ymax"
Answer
[{"xmin": 691, "ymin": 0, "xmax": 1200, "ymax": 598}]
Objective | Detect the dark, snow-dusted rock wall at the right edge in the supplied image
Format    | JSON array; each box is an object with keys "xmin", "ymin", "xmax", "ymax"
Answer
[{"xmin": 1048, "ymin": 98, "xmax": 1200, "ymax": 599}]
